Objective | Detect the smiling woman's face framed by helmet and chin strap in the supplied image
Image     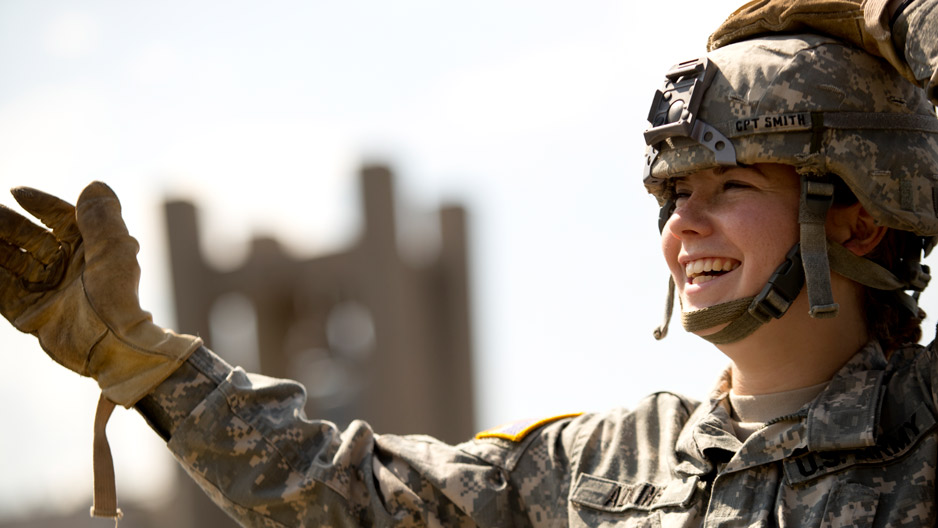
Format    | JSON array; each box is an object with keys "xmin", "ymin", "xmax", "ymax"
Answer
[{"xmin": 661, "ymin": 164, "xmax": 801, "ymax": 311}]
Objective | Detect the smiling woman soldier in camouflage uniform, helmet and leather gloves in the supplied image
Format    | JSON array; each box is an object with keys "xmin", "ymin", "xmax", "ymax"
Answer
[{"xmin": 0, "ymin": 0, "xmax": 938, "ymax": 526}]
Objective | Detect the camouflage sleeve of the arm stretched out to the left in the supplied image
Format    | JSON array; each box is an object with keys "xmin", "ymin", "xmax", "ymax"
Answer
[{"xmin": 138, "ymin": 349, "xmax": 580, "ymax": 527}]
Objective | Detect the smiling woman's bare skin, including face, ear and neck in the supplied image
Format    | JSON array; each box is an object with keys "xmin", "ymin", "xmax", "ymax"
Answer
[{"xmin": 662, "ymin": 163, "xmax": 890, "ymax": 394}]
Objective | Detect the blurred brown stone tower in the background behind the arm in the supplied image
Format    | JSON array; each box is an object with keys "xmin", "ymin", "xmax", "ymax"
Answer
[{"xmin": 166, "ymin": 166, "xmax": 474, "ymax": 528}]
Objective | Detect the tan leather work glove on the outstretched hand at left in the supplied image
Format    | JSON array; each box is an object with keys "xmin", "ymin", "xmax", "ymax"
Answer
[{"xmin": 0, "ymin": 182, "xmax": 202, "ymax": 407}]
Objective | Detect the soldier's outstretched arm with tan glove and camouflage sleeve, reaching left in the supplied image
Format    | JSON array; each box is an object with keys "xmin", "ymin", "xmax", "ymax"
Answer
[{"xmin": 0, "ymin": 183, "xmax": 569, "ymax": 527}]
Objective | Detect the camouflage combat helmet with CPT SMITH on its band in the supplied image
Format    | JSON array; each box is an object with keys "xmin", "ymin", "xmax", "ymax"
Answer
[{"xmin": 643, "ymin": 35, "xmax": 938, "ymax": 346}]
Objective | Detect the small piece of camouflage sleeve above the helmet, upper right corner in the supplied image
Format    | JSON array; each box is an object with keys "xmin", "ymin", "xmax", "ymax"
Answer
[{"xmin": 892, "ymin": 0, "xmax": 938, "ymax": 104}]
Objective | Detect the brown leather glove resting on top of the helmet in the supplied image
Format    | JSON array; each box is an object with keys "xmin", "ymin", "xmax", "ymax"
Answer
[{"xmin": 707, "ymin": 0, "xmax": 919, "ymax": 84}]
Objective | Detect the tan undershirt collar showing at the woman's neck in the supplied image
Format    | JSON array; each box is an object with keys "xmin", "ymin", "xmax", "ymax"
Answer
[{"xmin": 729, "ymin": 381, "xmax": 828, "ymax": 442}]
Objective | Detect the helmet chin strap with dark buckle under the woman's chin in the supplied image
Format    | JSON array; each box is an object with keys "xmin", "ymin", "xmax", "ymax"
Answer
[{"xmin": 655, "ymin": 175, "xmax": 927, "ymax": 345}]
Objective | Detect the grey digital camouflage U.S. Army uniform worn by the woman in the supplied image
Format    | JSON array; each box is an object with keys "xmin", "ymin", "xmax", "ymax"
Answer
[{"xmin": 137, "ymin": 5, "xmax": 938, "ymax": 527}]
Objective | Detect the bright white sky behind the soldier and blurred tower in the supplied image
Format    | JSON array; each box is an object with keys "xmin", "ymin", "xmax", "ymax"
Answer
[{"xmin": 0, "ymin": 0, "xmax": 938, "ymax": 518}]
